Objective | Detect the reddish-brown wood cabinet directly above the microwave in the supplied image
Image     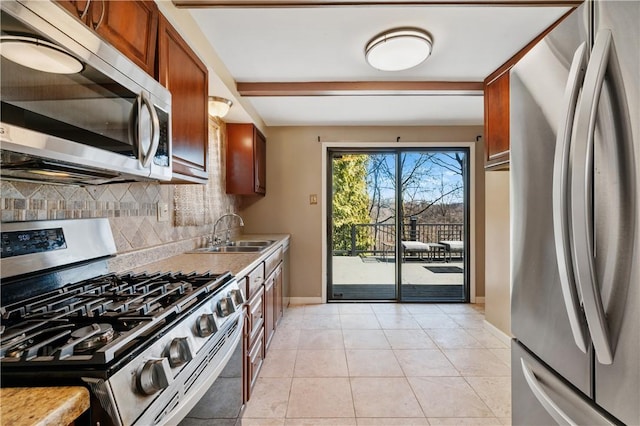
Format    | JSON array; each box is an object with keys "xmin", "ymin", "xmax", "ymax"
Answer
[{"xmin": 57, "ymin": 0, "xmax": 159, "ymax": 75}]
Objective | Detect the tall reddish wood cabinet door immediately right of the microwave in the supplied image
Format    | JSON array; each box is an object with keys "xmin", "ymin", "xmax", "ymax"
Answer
[{"xmin": 158, "ymin": 17, "xmax": 209, "ymax": 183}]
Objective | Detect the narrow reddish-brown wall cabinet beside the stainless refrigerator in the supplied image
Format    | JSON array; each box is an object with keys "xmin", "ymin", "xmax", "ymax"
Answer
[{"xmin": 484, "ymin": 71, "xmax": 509, "ymax": 169}]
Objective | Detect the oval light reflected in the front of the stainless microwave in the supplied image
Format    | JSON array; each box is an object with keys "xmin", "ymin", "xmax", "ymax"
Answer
[{"xmin": 0, "ymin": 36, "xmax": 83, "ymax": 74}]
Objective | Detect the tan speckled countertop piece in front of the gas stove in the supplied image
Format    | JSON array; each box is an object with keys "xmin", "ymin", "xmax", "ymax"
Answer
[{"xmin": 0, "ymin": 386, "xmax": 89, "ymax": 426}]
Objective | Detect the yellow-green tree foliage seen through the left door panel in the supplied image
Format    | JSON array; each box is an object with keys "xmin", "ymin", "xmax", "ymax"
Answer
[{"xmin": 333, "ymin": 154, "xmax": 373, "ymax": 250}]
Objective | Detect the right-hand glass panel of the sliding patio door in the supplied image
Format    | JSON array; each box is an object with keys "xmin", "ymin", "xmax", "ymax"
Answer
[{"xmin": 398, "ymin": 150, "xmax": 468, "ymax": 302}]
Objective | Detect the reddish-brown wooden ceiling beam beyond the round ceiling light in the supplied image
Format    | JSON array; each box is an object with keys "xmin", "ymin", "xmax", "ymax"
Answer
[{"xmin": 236, "ymin": 81, "xmax": 483, "ymax": 96}]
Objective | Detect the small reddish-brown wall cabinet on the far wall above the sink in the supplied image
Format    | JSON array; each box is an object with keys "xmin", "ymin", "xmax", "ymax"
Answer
[{"xmin": 227, "ymin": 123, "xmax": 267, "ymax": 195}]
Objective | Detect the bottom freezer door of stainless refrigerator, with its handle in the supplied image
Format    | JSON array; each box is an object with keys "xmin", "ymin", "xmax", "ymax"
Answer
[{"xmin": 511, "ymin": 341, "xmax": 615, "ymax": 425}]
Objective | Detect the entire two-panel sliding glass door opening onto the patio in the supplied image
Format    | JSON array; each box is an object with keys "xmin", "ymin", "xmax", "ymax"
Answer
[{"xmin": 327, "ymin": 149, "xmax": 469, "ymax": 302}]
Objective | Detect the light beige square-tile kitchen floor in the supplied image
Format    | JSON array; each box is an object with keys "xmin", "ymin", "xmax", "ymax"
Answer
[{"xmin": 242, "ymin": 303, "xmax": 511, "ymax": 426}]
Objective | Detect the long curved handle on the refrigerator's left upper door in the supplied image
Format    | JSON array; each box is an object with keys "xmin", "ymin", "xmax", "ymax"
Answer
[{"xmin": 552, "ymin": 43, "xmax": 587, "ymax": 353}]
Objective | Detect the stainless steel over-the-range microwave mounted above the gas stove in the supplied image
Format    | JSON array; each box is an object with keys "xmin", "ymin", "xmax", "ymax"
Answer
[{"xmin": 0, "ymin": 0, "xmax": 171, "ymax": 184}]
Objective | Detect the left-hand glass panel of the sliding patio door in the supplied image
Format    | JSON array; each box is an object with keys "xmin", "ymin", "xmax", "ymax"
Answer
[{"xmin": 328, "ymin": 151, "xmax": 398, "ymax": 300}]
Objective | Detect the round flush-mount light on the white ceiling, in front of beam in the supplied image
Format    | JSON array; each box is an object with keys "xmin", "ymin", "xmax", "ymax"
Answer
[{"xmin": 365, "ymin": 28, "xmax": 432, "ymax": 71}]
